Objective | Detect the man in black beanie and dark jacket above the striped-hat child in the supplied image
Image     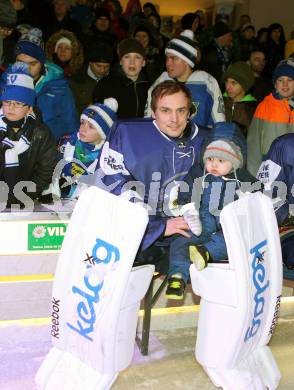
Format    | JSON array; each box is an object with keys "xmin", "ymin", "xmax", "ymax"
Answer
[{"xmin": 69, "ymin": 42, "xmax": 113, "ymax": 115}]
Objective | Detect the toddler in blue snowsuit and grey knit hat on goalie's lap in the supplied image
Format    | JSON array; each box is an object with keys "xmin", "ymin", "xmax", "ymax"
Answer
[{"xmin": 166, "ymin": 122, "xmax": 261, "ymax": 299}]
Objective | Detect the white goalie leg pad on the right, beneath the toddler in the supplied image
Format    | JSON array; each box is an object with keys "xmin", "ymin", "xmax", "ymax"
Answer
[{"xmin": 190, "ymin": 193, "xmax": 282, "ymax": 390}]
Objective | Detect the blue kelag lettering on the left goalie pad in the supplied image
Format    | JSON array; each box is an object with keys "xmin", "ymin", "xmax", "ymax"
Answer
[{"xmin": 66, "ymin": 238, "xmax": 120, "ymax": 341}]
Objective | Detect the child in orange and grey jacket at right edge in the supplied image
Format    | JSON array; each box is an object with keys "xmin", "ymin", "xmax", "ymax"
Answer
[{"xmin": 247, "ymin": 58, "xmax": 294, "ymax": 175}]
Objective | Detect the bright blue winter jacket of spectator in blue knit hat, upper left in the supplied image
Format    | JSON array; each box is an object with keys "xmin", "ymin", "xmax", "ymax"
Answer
[{"xmin": 35, "ymin": 62, "xmax": 79, "ymax": 140}]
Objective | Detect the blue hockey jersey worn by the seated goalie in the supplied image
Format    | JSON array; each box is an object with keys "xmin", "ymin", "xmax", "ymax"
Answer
[{"xmin": 95, "ymin": 119, "xmax": 206, "ymax": 250}]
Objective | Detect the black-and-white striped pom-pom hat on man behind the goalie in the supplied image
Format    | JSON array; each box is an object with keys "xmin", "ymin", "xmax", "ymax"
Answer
[{"xmin": 165, "ymin": 30, "xmax": 197, "ymax": 68}]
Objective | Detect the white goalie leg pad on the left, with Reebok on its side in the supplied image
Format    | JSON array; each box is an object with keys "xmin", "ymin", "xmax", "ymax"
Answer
[{"xmin": 36, "ymin": 187, "xmax": 154, "ymax": 390}]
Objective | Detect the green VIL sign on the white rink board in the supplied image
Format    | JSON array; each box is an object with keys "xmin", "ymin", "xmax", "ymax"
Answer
[{"xmin": 28, "ymin": 223, "xmax": 67, "ymax": 251}]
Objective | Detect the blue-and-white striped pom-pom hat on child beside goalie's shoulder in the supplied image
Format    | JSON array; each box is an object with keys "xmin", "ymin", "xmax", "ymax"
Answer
[{"xmin": 81, "ymin": 98, "xmax": 118, "ymax": 141}]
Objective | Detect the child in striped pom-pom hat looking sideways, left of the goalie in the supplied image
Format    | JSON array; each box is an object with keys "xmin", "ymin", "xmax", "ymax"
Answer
[{"xmin": 58, "ymin": 98, "xmax": 118, "ymax": 198}]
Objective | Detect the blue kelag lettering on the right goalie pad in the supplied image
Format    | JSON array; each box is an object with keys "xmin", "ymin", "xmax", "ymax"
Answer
[{"xmin": 244, "ymin": 240, "xmax": 270, "ymax": 342}]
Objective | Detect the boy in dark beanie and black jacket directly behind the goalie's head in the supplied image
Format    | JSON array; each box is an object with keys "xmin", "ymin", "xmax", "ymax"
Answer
[{"xmin": 93, "ymin": 38, "xmax": 148, "ymax": 118}]
